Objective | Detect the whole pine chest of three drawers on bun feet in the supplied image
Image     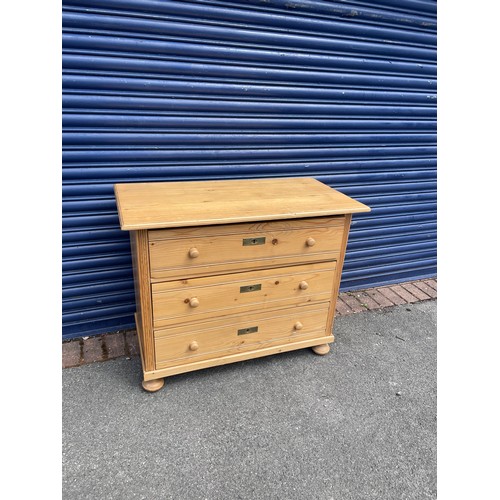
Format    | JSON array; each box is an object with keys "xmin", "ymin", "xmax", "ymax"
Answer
[{"xmin": 115, "ymin": 178, "xmax": 370, "ymax": 391}]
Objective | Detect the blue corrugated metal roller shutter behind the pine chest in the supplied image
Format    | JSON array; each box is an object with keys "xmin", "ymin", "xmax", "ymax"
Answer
[{"xmin": 62, "ymin": 0, "xmax": 436, "ymax": 338}]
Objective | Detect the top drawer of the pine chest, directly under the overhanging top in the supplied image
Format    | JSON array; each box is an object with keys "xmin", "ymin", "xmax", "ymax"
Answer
[{"xmin": 148, "ymin": 216, "xmax": 345, "ymax": 282}]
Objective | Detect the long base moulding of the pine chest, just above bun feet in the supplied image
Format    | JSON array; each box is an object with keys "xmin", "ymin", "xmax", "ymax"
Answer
[{"xmin": 144, "ymin": 335, "xmax": 333, "ymax": 380}]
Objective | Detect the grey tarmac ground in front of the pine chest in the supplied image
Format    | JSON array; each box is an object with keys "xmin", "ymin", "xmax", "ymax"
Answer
[{"xmin": 62, "ymin": 300, "xmax": 437, "ymax": 500}]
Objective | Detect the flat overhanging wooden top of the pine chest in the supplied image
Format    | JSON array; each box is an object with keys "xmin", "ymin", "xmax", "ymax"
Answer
[{"xmin": 115, "ymin": 177, "xmax": 370, "ymax": 230}]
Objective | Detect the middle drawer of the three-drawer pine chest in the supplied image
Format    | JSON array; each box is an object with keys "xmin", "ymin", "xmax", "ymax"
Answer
[{"xmin": 148, "ymin": 261, "xmax": 337, "ymax": 328}]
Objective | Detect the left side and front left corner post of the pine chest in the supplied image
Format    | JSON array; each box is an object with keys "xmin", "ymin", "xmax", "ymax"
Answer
[{"xmin": 130, "ymin": 231, "xmax": 155, "ymax": 370}]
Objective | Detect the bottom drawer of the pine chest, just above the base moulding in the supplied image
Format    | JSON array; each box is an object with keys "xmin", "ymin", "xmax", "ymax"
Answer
[{"xmin": 155, "ymin": 303, "xmax": 329, "ymax": 369}]
